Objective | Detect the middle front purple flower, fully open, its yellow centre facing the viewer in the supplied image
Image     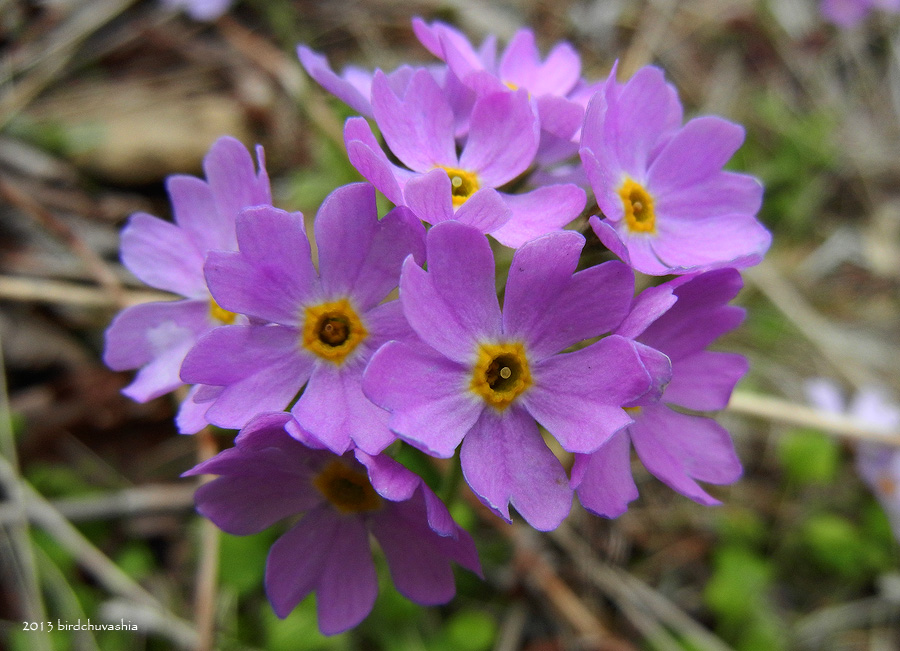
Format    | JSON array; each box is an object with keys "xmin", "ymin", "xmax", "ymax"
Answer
[{"xmin": 363, "ymin": 221, "xmax": 669, "ymax": 530}]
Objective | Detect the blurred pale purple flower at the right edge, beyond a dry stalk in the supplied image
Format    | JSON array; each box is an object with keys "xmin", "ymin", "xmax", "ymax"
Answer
[{"xmin": 806, "ymin": 379, "xmax": 900, "ymax": 540}]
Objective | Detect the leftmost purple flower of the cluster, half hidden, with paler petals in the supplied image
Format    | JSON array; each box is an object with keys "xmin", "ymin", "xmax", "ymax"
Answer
[{"xmin": 103, "ymin": 137, "xmax": 272, "ymax": 432}]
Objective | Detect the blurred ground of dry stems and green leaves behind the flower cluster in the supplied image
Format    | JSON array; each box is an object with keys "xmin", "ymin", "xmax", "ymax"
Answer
[{"xmin": 0, "ymin": 0, "xmax": 900, "ymax": 651}]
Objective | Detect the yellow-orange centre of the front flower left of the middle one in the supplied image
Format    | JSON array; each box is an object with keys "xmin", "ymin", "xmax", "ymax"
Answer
[{"xmin": 303, "ymin": 298, "xmax": 369, "ymax": 364}]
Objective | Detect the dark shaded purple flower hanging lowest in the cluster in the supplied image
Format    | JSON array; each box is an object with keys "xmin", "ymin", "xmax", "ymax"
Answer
[{"xmin": 185, "ymin": 413, "xmax": 481, "ymax": 635}]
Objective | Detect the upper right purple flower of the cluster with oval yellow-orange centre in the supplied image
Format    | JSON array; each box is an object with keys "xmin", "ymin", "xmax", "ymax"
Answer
[{"xmin": 580, "ymin": 67, "xmax": 771, "ymax": 275}]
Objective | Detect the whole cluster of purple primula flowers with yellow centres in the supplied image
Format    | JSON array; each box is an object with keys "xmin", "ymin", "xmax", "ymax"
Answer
[{"xmin": 105, "ymin": 19, "xmax": 770, "ymax": 633}]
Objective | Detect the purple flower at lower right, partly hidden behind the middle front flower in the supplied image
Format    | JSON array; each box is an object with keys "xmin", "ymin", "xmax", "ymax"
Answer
[{"xmin": 572, "ymin": 269, "xmax": 747, "ymax": 518}]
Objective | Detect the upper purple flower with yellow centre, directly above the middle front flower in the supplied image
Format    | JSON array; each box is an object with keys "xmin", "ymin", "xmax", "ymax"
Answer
[{"xmin": 344, "ymin": 70, "xmax": 585, "ymax": 247}]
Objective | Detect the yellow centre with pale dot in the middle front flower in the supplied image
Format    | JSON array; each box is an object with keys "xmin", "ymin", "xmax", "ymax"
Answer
[{"xmin": 470, "ymin": 341, "xmax": 534, "ymax": 411}]
